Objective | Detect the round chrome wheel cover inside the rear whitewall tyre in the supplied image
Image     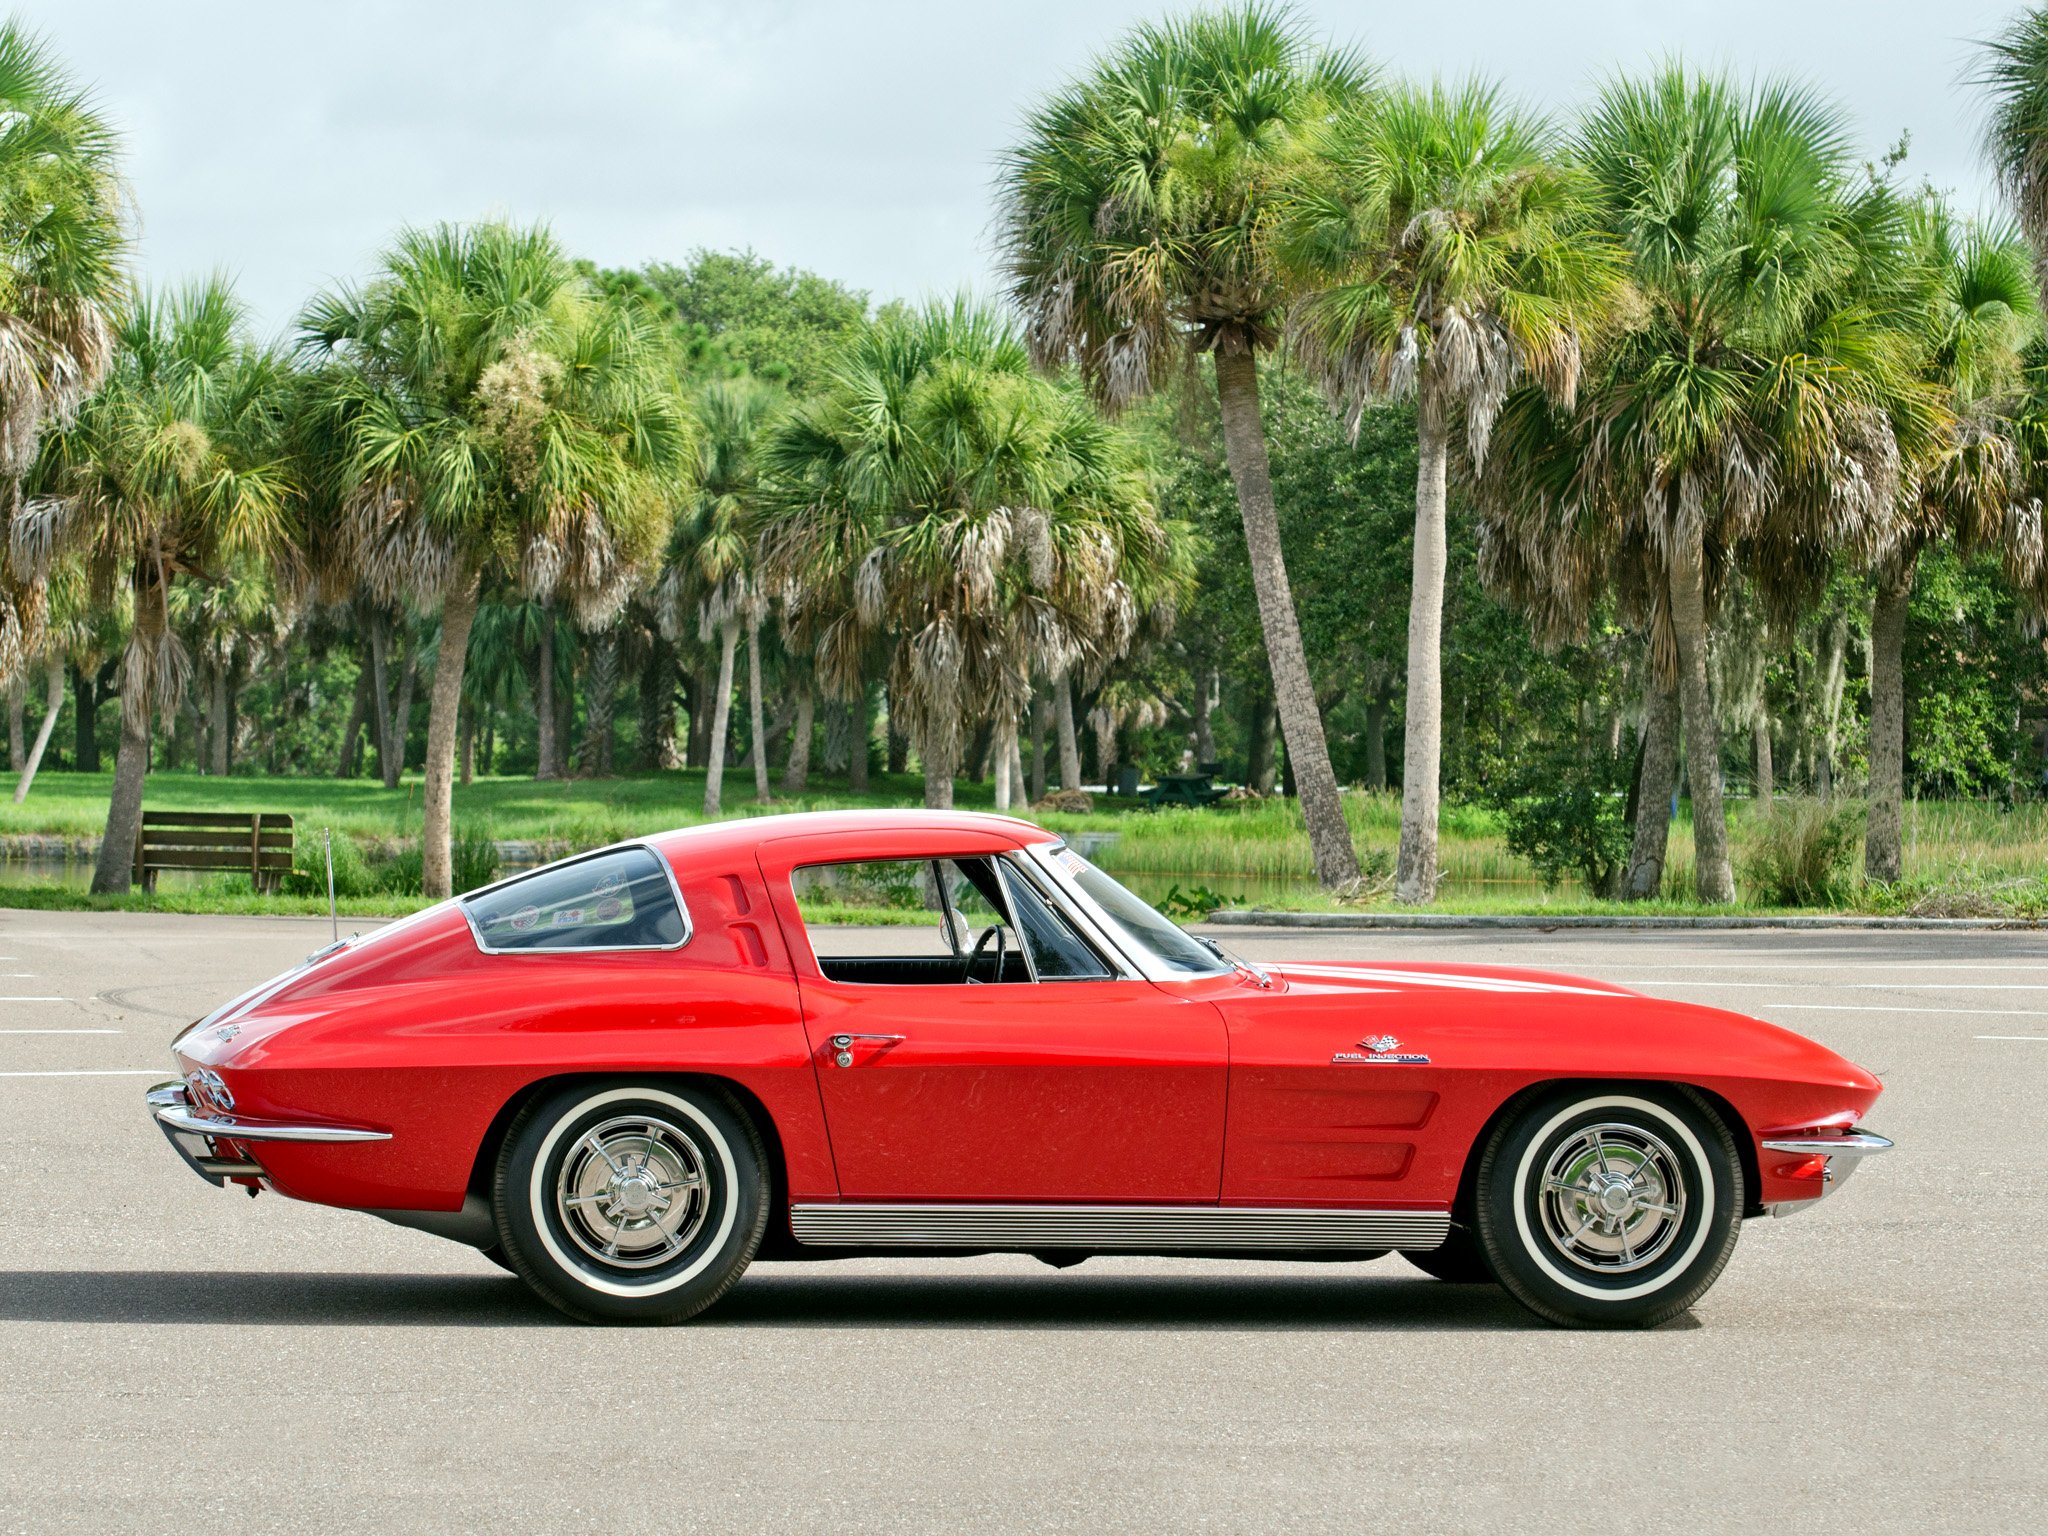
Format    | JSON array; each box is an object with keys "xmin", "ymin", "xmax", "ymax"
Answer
[{"xmin": 555, "ymin": 1114, "xmax": 711, "ymax": 1270}]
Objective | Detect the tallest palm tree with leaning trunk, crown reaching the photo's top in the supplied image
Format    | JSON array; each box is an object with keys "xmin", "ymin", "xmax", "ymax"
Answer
[{"xmin": 999, "ymin": 4, "xmax": 1368, "ymax": 885}]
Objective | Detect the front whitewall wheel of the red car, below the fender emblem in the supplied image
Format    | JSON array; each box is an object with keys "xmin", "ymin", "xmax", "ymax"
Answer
[{"xmin": 1477, "ymin": 1085, "xmax": 1743, "ymax": 1327}]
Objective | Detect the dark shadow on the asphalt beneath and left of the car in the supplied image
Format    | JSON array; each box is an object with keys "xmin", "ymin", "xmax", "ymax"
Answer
[{"xmin": 0, "ymin": 1268, "xmax": 1700, "ymax": 1333}]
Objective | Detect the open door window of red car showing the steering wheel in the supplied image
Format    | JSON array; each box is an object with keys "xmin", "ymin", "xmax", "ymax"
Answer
[{"xmin": 791, "ymin": 858, "xmax": 1030, "ymax": 985}]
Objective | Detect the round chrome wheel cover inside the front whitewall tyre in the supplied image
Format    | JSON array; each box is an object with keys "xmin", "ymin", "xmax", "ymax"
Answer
[{"xmin": 1536, "ymin": 1122, "xmax": 1688, "ymax": 1274}]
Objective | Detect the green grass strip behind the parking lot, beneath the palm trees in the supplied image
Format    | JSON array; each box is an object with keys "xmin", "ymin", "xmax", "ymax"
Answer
[{"xmin": 12, "ymin": 772, "xmax": 2048, "ymax": 915}]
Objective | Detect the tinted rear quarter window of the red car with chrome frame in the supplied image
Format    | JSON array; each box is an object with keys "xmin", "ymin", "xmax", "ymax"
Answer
[{"xmin": 463, "ymin": 848, "xmax": 690, "ymax": 952}]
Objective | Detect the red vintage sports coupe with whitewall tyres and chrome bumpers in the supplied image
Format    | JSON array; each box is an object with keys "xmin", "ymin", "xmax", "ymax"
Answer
[{"xmin": 150, "ymin": 811, "xmax": 1890, "ymax": 1325}]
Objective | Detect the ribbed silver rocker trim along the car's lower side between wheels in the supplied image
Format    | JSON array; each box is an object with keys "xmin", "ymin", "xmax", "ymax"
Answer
[{"xmin": 788, "ymin": 1202, "xmax": 1450, "ymax": 1251}]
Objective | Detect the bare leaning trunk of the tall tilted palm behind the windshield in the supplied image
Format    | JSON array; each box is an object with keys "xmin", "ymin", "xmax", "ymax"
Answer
[{"xmin": 1217, "ymin": 334, "xmax": 1351, "ymax": 887}]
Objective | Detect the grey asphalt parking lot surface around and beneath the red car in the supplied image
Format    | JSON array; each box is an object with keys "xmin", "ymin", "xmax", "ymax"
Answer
[{"xmin": 0, "ymin": 911, "xmax": 2048, "ymax": 1536}]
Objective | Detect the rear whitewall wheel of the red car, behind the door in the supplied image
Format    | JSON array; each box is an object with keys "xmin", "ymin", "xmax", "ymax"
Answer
[{"xmin": 494, "ymin": 1083, "xmax": 768, "ymax": 1323}]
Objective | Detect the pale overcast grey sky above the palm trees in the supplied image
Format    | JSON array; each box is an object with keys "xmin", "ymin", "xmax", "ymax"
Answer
[{"xmin": 14, "ymin": 0, "xmax": 2015, "ymax": 328}]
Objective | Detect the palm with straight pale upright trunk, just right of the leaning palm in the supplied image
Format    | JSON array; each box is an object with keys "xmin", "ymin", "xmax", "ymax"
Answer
[{"xmin": 1284, "ymin": 82, "xmax": 1620, "ymax": 901}]
